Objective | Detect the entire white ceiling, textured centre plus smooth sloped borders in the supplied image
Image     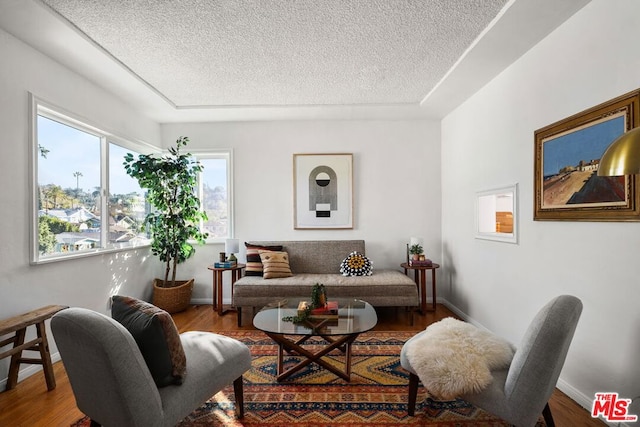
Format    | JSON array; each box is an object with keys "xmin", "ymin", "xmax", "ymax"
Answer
[{"xmin": 0, "ymin": 0, "xmax": 589, "ymax": 123}]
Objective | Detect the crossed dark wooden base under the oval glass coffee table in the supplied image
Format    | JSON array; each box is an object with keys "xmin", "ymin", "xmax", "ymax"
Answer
[{"xmin": 265, "ymin": 332, "xmax": 360, "ymax": 382}]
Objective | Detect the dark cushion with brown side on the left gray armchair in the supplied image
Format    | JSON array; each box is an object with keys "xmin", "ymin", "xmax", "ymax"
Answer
[{"xmin": 111, "ymin": 295, "xmax": 187, "ymax": 387}]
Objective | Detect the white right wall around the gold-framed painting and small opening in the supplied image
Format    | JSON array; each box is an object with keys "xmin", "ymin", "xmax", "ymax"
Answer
[{"xmin": 442, "ymin": 0, "xmax": 640, "ymax": 408}]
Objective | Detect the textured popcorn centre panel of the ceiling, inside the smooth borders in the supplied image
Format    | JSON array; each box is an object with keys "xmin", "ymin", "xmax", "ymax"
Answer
[{"xmin": 44, "ymin": 0, "xmax": 507, "ymax": 106}]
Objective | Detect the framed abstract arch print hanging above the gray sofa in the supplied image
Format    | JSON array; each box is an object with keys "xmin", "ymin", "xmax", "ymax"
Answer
[{"xmin": 293, "ymin": 153, "xmax": 353, "ymax": 230}]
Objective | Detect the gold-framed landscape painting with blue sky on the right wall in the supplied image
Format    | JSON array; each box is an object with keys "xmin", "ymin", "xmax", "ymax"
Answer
[{"xmin": 533, "ymin": 90, "xmax": 640, "ymax": 221}]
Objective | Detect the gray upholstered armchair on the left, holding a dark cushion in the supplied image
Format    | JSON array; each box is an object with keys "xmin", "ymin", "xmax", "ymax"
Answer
[{"xmin": 51, "ymin": 308, "xmax": 251, "ymax": 427}]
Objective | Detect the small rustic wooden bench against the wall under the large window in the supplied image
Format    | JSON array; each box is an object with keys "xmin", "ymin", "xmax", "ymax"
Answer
[{"xmin": 0, "ymin": 305, "xmax": 68, "ymax": 390}]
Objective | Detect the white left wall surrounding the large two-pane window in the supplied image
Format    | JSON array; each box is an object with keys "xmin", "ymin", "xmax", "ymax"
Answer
[{"xmin": 0, "ymin": 30, "xmax": 160, "ymax": 389}]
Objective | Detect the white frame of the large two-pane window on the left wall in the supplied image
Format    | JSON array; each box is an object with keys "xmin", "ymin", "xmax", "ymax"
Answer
[{"xmin": 29, "ymin": 93, "xmax": 160, "ymax": 264}]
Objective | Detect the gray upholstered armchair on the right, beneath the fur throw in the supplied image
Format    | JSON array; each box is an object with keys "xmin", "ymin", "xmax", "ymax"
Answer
[{"xmin": 400, "ymin": 295, "xmax": 582, "ymax": 427}]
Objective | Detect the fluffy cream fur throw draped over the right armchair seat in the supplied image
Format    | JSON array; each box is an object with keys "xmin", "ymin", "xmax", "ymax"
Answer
[{"xmin": 406, "ymin": 317, "xmax": 514, "ymax": 400}]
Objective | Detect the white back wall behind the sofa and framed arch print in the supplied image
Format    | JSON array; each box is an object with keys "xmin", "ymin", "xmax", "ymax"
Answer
[{"xmin": 162, "ymin": 121, "xmax": 441, "ymax": 303}]
